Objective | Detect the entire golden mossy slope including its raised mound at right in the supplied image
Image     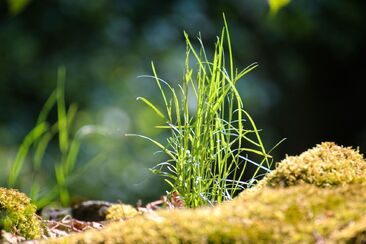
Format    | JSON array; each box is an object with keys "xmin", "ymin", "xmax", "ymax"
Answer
[{"xmin": 44, "ymin": 143, "xmax": 366, "ymax": 243}]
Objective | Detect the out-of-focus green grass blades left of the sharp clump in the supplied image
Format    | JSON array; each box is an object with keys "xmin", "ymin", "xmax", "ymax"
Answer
[{"xmin": 7, "ymin": 67, "xmax": 105, "ymax": 208}]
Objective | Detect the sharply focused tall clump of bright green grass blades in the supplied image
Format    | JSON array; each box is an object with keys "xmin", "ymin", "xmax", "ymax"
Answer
[{"xmin": 130, "ymin": 16, "xmax": 280, "ymax": 207}]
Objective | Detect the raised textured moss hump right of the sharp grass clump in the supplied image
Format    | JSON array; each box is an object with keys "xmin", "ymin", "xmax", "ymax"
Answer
[{"xmin": 256, "ymin": 142, "xmax": 366, "ymax": 188}]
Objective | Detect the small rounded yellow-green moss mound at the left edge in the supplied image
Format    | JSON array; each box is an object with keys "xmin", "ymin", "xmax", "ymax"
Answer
[{"xmin": 0, "ymin": 187, "xmax": 42, "ymax": 239}]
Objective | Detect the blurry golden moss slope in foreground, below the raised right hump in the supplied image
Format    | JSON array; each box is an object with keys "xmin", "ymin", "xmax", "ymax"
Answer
[{"xmin": 49, "ymin": 184, "xmax": 366, "ymax": 243}]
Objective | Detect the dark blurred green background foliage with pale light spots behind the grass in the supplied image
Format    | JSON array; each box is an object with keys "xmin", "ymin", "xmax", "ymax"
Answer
[{"xmin": 0, "ymin": 0, "xmax": 366, "ymax": 203}]
